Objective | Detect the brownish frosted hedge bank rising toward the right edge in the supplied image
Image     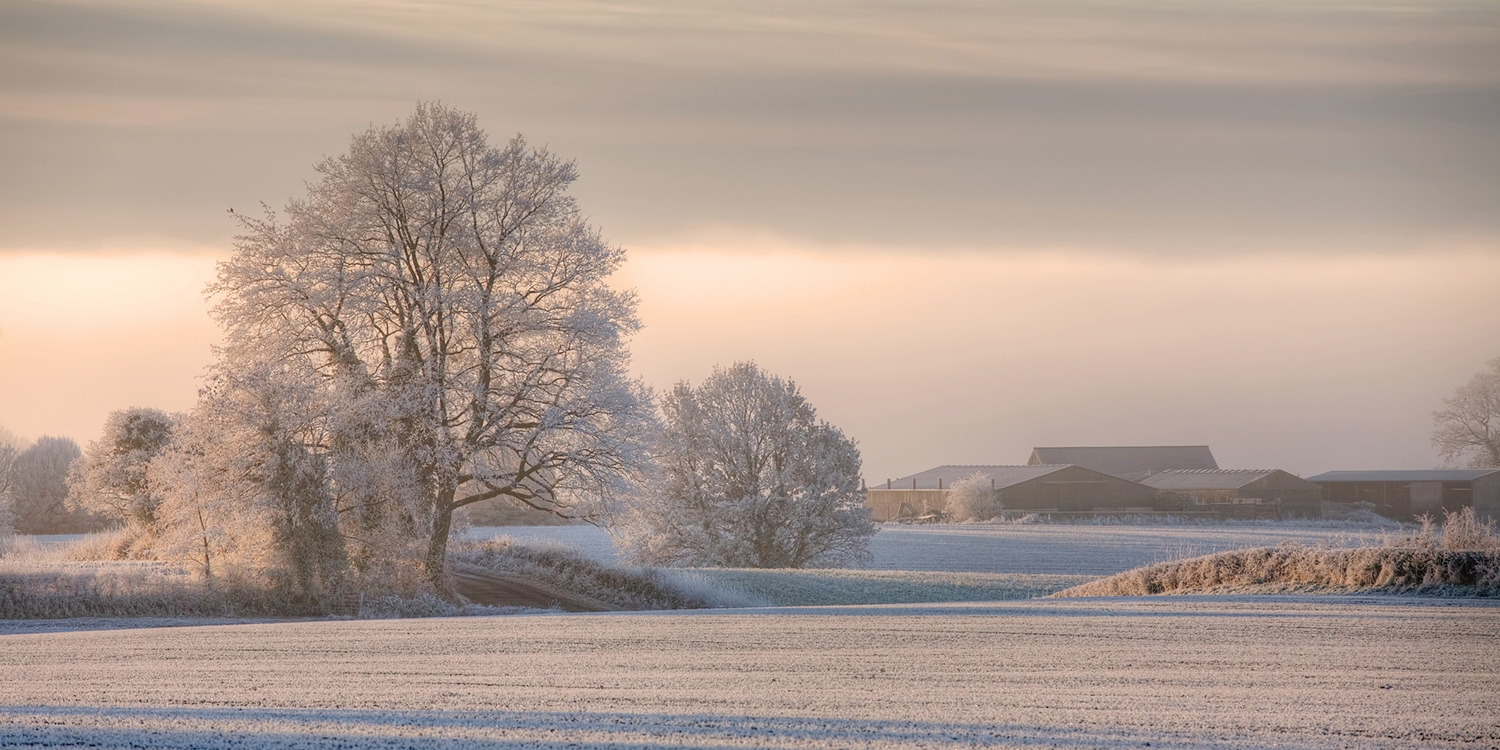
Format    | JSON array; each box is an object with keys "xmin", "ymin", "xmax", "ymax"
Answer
[{"xmin": 1056, "ymin": 509, "xmax": 1500, "ymax": 597}]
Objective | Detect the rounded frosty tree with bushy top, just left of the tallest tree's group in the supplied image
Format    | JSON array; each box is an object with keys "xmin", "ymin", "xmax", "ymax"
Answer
[{"xmin": 68, "ymin": 407, "xmax": 177, "ymax": 545}]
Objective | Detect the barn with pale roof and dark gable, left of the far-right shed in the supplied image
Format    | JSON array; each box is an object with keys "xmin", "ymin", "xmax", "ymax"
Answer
[{"xmin": 1140, "ymin": 470, "xmax": 1323, "ymax": 518}]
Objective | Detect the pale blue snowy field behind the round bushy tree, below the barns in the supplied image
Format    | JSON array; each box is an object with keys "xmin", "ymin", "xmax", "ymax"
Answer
[{"xmin": 470, "ymin": 524, "xmax": 1380, "ymax": 576}]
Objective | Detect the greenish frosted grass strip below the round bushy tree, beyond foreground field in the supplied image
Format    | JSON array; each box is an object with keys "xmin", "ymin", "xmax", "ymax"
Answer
[{"xmin": 662, "ymin": 569, "xmax": 1092, "ymax": 606}]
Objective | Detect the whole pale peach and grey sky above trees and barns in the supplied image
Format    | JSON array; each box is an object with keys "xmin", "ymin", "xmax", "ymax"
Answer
[{"xmin": 0, "ymin": 0, "xmax": 1500, "ymax": 483}]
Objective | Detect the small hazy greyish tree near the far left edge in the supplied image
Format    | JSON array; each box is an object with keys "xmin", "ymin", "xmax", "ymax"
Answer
[{"xmin": 11, "ymin": 435, "xmax": 102, "ymax": 534}]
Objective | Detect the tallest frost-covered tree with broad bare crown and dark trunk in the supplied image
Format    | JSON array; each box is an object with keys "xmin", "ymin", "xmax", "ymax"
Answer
[{"xmin": 212, "ymin": 104, "xmax": 654, "ymax": 591}]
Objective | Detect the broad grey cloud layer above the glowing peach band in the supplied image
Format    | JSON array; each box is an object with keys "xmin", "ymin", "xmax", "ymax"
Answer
[{"xmin": 0, "ymin": 0, "xmax": 1500, "ymax": 255}]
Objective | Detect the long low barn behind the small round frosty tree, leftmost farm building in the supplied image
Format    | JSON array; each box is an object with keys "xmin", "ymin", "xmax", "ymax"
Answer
[{"xmin": 864, "ymin": 465, "xmax": 1158, "ymax": 521}]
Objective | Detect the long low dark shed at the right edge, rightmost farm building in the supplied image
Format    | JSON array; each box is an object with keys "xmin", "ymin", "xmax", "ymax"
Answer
[{"xmin": 1308, "ymin": 470, "xmax": 1500, "ymax": 519}]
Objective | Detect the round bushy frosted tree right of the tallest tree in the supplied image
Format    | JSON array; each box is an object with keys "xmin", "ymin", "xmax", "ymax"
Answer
[{"xmin": 618, "ymin": 363, "xmax": 875, "ymax": 567}]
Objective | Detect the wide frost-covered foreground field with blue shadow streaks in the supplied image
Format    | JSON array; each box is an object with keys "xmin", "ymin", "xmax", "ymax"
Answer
[{"xmin": 0, "ymin": 597, "xmax": 1500, "ymax": 749}]
